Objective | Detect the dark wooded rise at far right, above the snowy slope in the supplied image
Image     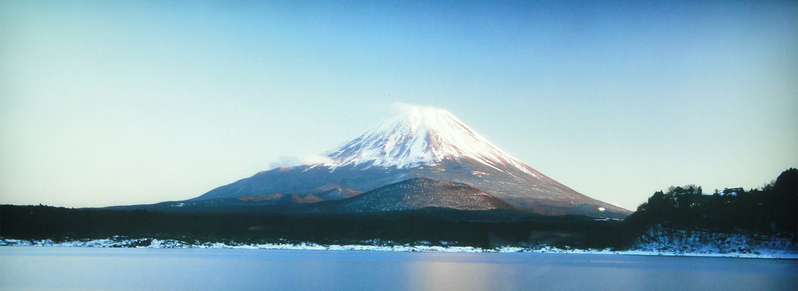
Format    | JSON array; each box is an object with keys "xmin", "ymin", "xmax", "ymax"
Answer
[{"xmin": 624, "ymin": 168, "xmax": 798, "ymax": 244}]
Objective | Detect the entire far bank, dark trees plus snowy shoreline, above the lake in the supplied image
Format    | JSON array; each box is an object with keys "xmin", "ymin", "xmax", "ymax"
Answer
[{"xmin": 0, "ymin": 168, "xmax": 798, "ymax": 257}]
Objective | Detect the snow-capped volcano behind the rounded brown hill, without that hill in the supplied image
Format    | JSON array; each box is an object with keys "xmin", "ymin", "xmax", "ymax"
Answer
[{"xmin": 192, "ymin": 107, "xmax": 631, "ymax": 218}]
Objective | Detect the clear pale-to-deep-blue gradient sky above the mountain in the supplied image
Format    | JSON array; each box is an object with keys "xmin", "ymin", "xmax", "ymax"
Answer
[{"xmin": 0, "ymin": 0, "xmax": 798, "ymax": 210}]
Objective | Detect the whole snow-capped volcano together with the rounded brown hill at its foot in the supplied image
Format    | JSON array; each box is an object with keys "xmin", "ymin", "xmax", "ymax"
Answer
[{"xmin": 188, "ymin": 107, "xmax": 631, "ymax": 218}]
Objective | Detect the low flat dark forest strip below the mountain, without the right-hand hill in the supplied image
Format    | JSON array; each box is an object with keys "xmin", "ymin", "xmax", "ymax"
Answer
[{"xmin": 0, "ymin": 205, "xmax": 620, "ymax": 248}]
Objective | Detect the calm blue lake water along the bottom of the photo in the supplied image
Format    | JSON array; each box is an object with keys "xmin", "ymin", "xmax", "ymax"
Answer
[{"xmin": 0, "ymin": 247, "xmax": 798, "ymax": 291}]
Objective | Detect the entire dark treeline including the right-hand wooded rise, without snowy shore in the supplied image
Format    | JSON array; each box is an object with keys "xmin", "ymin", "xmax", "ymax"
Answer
[{"xmin": 0, "ymin": 169, "xmax": 798, "ymax": 248}]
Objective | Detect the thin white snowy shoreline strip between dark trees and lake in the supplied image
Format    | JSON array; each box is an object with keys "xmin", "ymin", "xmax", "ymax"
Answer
[{"xmin": 0, "ymin": 237, "xmax": 798, "ymax": 260}]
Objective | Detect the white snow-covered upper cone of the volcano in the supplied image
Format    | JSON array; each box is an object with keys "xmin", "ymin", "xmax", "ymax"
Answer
[{"xmin": 324, "ymin": 107, "xmax": 531, "ymax": 174}]
